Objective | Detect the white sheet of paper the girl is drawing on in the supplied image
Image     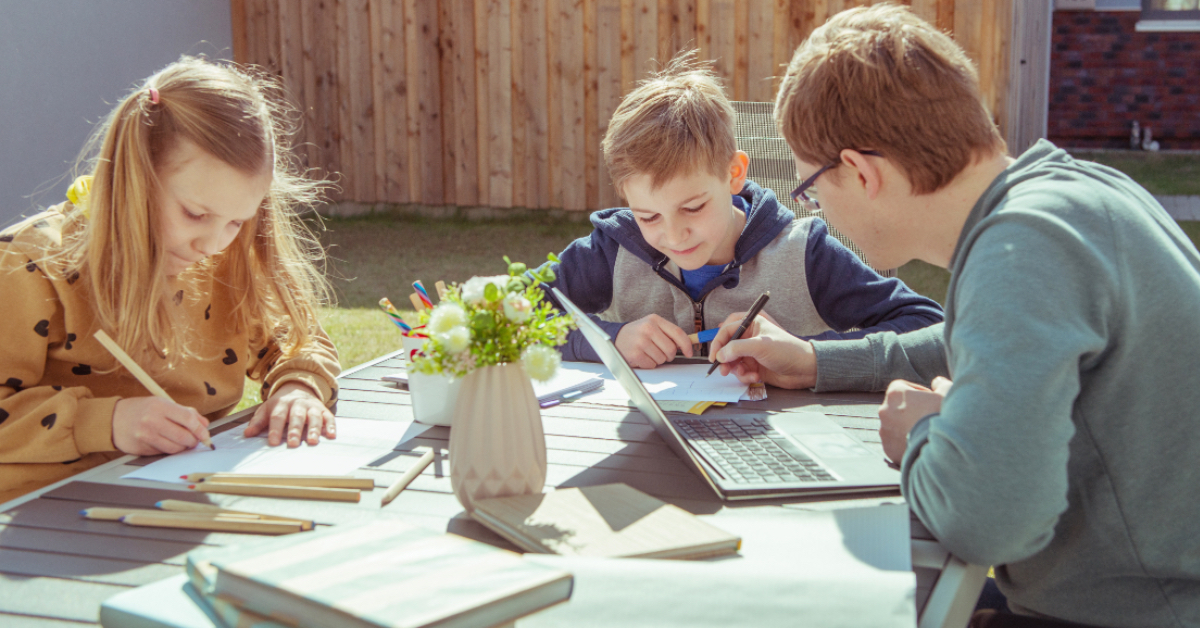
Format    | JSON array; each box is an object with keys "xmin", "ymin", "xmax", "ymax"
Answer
[{"xmin": 122, "ymin": 418, "xmax": 412, "ymax": 484}]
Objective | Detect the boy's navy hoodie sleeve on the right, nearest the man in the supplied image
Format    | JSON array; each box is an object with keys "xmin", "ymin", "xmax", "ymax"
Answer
[{"xmin": 804, "ymin": 220, "xmax": 943, "ymax": 340}]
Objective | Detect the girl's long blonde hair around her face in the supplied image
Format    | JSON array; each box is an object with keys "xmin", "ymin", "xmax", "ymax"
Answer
[{"xmin": 55, "ymin": 56, "xmax": 331, "ymax": 367}]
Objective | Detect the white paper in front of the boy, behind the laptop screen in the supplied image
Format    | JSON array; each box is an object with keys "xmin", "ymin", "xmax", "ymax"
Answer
[{"xmin": 560, "ymin": 361, "xmax": 749, "ymax": 405}]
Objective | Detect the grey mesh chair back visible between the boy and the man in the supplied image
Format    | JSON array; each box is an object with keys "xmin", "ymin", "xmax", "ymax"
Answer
[{"xmin": 733, "ymin": 102, "xmax": 895, "ymax": 277}]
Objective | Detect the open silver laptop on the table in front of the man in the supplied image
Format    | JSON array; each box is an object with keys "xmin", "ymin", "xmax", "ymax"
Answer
[{"xmin": 551, "ymin": 288, "xmax": 900, "ymax": 501}]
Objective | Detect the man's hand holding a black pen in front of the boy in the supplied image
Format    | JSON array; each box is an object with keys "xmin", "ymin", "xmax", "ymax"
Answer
[{"xmin": 709, "ymin": 312, "xmax": 817, "ymax": 388}]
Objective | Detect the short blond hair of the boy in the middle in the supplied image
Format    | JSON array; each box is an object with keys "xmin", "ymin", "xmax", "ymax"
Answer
[{"xmin": 601, "ymin": 50, "xmax": 737, "ymax": 196}]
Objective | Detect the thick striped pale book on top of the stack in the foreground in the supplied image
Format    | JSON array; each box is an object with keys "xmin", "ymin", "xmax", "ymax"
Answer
[{"xmin": 211, "ymin": 520, "xmax": 572, "ymax": 628}]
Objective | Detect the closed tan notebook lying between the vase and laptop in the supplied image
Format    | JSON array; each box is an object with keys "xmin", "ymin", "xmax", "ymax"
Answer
[{"xmin": 472, "ymin": 484, "xmax": 742, "ymax": 558}]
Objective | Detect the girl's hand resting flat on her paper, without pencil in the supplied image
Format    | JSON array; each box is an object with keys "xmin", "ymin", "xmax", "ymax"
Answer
[{"xmin": 245, "ymin": 382, "xmax": 337, "ymax": 447}]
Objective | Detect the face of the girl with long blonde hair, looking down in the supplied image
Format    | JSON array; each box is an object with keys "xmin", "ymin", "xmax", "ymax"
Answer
[{"xmin": 157, "ymin": 140, "xmax": 272, "ymax": 276}]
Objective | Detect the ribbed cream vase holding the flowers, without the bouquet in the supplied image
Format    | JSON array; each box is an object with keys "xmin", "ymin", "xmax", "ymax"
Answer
[{"xmin": 450, "ymin": 363, "xmax": 546, "ymax": 513}]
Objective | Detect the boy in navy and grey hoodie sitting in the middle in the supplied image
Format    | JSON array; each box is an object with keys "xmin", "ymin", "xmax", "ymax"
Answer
[{"xmin": 540, "ymin": 53, "xmax": 942, "ymax": 369}]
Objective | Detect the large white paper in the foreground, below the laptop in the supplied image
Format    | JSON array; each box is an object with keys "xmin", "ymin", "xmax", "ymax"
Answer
[{"xmin": 517, "ymin": 504, "xmax": 917, "ymax": 628}]
